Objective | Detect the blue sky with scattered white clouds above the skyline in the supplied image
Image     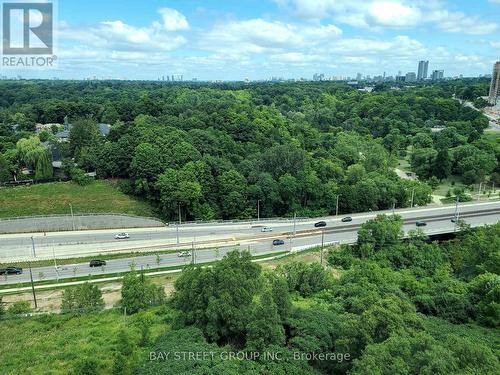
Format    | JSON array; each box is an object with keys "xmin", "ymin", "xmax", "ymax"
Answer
[{"xmin": 1, "ymin": 0, "xmax": 500, "ymax": 80}]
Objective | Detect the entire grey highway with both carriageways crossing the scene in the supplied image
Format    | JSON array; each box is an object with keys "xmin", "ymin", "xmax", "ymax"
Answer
[{"xmin": 0, "ymin": 202, "xmax": 500, "ymax": 284}]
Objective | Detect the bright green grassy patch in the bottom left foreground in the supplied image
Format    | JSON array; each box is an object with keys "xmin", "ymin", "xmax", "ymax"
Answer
[{"xmin": 0, "ymin": 307, "xmax": 170, "ymax": 375}]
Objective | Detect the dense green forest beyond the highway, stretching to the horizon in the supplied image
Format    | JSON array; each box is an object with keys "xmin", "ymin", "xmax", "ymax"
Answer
[{"xmin": 0, "ymin": 80, "xmax": 500, "ymax": 220}]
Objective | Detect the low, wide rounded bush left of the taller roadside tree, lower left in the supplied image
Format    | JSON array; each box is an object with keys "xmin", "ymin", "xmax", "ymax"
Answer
[{"xmin": 61, "ymin": 282, "xmax": 104, "ymax": 312}]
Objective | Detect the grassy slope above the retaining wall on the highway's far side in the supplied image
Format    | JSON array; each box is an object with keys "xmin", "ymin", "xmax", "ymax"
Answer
[{"xmin": 0, "ymin": 181, "xmax": 154, "ymax": 218}]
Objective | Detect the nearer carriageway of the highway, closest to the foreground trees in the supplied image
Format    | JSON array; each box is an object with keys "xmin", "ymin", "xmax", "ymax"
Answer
[{"xmin": 0, "ymin": 205, "xmax": 500, "ymax": 284}]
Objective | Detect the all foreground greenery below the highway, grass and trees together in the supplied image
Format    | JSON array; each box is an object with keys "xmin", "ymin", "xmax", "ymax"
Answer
[{"xmin": 0, "ymin": 216, "xmax": 500, "ymax": 375}]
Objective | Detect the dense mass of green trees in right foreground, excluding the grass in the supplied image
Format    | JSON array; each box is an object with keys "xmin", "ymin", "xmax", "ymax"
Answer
[{"xmin": 140, "ymin": 222, "xmax": 500, "ymax": 375}]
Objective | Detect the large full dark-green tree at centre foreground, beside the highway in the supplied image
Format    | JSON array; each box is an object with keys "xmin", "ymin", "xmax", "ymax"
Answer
[{"xmin": 173, "ymin": 251, "xmax": 261, "ymax": 347}]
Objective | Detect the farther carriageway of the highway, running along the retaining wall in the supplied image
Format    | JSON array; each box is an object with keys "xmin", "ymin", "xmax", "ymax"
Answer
[{"xmin": 0, "ymin": 201, "xmax": 500, "ymax": 262}]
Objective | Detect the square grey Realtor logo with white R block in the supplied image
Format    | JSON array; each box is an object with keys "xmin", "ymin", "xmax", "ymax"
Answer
[{"xmin": 2, "ymin": 2, "xmax": 54, "ymax": 55}]
